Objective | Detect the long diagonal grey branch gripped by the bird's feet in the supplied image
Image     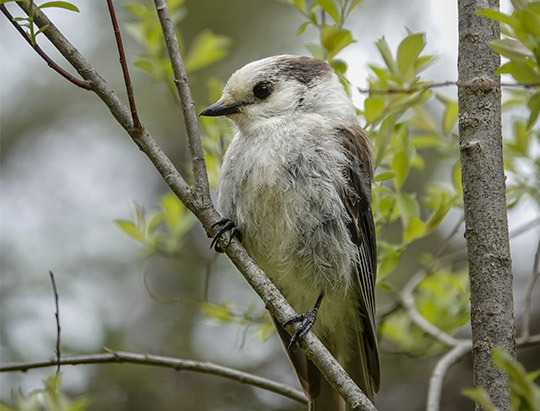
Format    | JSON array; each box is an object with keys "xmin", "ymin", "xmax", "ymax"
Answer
[{"xmin": 9, "ymin": 3, "xmax": 375, "ymax": 411}]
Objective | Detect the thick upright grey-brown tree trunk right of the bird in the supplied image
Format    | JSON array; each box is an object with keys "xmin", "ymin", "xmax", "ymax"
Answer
[{"xmin": 458, "ymin": 0, "xmax": 515, "ymax": 410}]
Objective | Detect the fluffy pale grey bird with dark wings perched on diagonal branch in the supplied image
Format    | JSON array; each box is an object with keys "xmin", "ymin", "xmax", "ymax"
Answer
[{"xmin": 200, "ymin": 54, "xmax": 380, "ymax": 411}]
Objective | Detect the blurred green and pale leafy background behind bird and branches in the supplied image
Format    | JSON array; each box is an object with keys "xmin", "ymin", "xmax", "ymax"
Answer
[{"xmin": 0, "ymin": 0, "xmax": 540, "ymax": 411}]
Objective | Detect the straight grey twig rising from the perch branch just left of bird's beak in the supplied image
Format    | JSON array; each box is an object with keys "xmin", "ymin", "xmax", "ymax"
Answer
[{"xmin": 154, "ymin": 0, "xmax": 211, "ymax": 204}]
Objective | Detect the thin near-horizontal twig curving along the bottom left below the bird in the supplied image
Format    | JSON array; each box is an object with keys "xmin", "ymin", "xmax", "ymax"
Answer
[{"xmin": 0, "ymin": 350, "xmax": 307, "ymax": 404}]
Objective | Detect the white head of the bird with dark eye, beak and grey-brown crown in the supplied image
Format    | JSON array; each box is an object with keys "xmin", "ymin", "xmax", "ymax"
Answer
[{"xmin": 201, "ymin": 55, "xmax": 356, "ymax": 129}]
